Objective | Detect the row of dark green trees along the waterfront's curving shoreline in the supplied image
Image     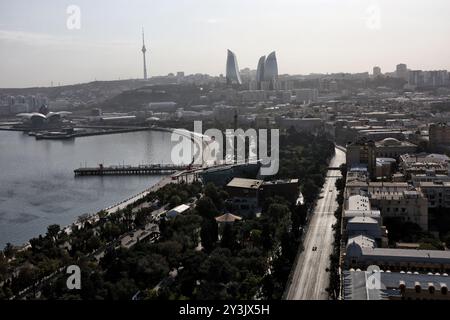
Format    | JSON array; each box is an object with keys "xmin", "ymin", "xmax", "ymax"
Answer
[{"xmin": 0, "ymin": 182, "xmax": 202, "ymax": 299}]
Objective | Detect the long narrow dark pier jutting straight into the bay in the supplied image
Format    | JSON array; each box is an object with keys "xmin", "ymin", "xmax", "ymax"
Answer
[{"xmin": 74, "ymin": 164, "xmax": 192, "ymax": 177}]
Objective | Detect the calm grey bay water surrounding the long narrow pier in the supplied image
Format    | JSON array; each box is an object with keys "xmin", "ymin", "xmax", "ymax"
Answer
[{"xmin": 0, "ymin": 130, "xmax": 176, "ymax": 247}]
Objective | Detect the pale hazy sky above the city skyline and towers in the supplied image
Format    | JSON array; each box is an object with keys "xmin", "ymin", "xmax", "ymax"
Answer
[{"xmin": 0, "ymin": 0, "xmax": 450, "ymax": 87}]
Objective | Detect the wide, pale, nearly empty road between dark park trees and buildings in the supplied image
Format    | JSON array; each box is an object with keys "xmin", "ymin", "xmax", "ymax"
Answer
[{"xmin": 286, "ymin": 148, "xmax": 345, "ymax": 300}]
